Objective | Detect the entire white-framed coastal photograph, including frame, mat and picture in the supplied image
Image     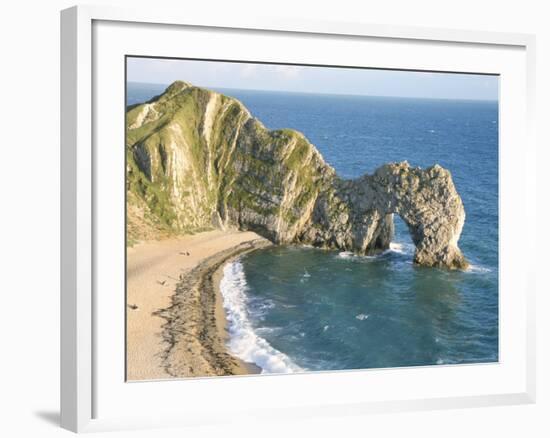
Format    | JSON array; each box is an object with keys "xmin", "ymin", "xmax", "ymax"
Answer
[{"xmin": 61, "ymin": 7, "xmax": 536, "ymax": 431}]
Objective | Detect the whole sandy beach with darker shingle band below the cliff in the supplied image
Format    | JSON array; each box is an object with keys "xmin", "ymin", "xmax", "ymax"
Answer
[{"xmin": 126, "ymin": 230, "xmax": 270, "ymax": 381}]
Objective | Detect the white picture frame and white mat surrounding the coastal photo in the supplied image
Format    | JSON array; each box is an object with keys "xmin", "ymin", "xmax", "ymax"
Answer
[{"xmin": 61, "ymin": 6, "xmax": 536, "ymax": 432}]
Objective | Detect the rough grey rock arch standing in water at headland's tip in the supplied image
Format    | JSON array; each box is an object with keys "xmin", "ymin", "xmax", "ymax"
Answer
[{"xmin": 347, "ymin": 162, "xmax": 468, "ymax": 269}]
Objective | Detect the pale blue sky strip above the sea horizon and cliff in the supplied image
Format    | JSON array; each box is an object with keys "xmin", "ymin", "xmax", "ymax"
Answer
[{"xmin": 127, "ymin": 58, "xmax": 498, "ymax": 100}]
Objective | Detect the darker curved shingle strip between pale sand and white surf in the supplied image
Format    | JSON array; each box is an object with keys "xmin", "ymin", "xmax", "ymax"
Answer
[{"xmin": 155, "ymin": 238, "xmax": 271, "ymax": 378}]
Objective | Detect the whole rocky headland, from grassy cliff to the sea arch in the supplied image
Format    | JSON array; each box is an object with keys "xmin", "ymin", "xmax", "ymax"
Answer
[{"xmin": 126, "ymin": 81, "xmax": 467, "ymax": 268}]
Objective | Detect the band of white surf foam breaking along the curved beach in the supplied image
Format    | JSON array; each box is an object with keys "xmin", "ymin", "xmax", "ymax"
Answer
[{"xmin": 220, "ymin": 260, "xmax": 303, "ymax": 373}]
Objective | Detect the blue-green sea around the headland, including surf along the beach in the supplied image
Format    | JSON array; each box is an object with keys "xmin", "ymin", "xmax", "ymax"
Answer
[{"xmin": 127, "ymin": 83, "xmax": 499, "ymax": 373}]
